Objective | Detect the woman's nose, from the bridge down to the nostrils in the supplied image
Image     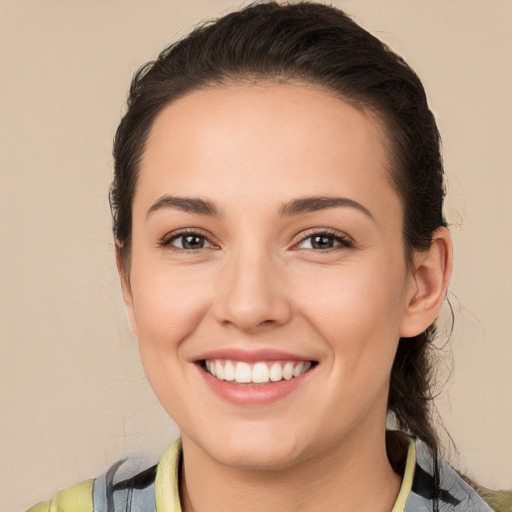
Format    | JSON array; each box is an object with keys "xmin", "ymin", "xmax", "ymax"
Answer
[{"xmin": 214, "ymin": 249, "xmax": 292, "ymax": 333}]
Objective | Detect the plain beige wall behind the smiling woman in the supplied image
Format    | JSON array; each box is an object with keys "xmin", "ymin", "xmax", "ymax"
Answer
[{"xmin": 0, "ymin": 0, "xmax": 512, "ymax": 512}]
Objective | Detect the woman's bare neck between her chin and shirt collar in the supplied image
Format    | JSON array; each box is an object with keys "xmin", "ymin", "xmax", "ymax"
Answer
[{"xmin": 180, "ymin": 432, "xmax": 401, "ymax": 512}]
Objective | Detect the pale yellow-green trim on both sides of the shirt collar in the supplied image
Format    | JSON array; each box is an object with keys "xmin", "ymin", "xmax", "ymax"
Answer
[{"xmin": 155, "ymin": 438, "xmax": 416, "ymax": 512}]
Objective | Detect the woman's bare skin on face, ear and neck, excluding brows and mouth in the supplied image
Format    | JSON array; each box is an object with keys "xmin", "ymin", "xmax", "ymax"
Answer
[{"xmin": 120, "ymin": 83, "xmax": 451, "ymax": 512}]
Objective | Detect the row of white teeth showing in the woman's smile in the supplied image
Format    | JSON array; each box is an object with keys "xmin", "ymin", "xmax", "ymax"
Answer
[{"xmin": 200, "ymin": 359, "xmax": 317, "ymax": 384}]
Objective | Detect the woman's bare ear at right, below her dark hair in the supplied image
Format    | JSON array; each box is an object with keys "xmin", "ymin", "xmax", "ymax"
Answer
[{"xmin": 400, "ymin": 227, "xmax": 453, "ymax": 338}]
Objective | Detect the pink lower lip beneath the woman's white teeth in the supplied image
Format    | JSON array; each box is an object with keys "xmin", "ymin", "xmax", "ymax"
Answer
[{"xmin": 197, "ymin": 365, "xmax": 313, "ymax": 406}]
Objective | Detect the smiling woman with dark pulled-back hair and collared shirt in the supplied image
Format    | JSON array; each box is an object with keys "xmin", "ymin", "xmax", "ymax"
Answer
[{"xmin": 26, "ymin": 3, "xmax": 502, "ymax": 512}]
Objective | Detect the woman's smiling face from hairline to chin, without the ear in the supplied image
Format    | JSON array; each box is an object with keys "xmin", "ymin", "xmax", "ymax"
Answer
[{"xmin": 124, "ymin": 84, "xmax": 420, "ymax": 468}]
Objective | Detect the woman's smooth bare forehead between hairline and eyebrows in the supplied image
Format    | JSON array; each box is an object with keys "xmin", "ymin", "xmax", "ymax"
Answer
[{"xmin": 135, "ymin": 83, "xmax": 396, "ymax": 220}]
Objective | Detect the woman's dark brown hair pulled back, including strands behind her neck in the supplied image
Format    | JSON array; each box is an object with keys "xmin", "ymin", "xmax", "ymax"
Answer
[{"xmin": 110, "ymin": 2, "xmax": 445, "ymax": 492}]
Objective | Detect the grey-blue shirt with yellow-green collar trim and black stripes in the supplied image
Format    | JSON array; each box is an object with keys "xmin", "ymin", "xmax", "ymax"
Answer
[{"xmin": 27, "ymin": 438, "xmax": 492, "ymax": 512}]
